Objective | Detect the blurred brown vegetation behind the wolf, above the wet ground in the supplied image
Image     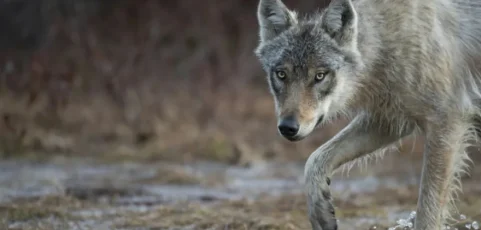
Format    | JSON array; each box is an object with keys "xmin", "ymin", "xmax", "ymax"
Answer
[{"xmin": 0, "ymin": 0, "xmax": 344, "ymax": 163}]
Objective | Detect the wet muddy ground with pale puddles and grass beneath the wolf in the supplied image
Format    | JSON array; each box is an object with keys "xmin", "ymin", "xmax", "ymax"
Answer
[{"xmin": 0, "ymin": 152, "xmax": 481, "ymax": 230}]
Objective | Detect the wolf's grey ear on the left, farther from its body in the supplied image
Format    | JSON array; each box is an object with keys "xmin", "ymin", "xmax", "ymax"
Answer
[{"xmin": 257, "ymin": 0, "xmax": 297, "ymax": 42}]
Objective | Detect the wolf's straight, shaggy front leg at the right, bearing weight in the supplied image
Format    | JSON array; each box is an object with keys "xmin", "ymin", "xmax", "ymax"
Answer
[{"xmin": 415, "ymin": 121, "xmax": 469, "ymax": 230}]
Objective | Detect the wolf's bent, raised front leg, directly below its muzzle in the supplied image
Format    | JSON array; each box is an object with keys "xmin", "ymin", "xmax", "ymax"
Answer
[{"xmin": 304, "ymin": 114, "xmax": 413, "ymax": 230}]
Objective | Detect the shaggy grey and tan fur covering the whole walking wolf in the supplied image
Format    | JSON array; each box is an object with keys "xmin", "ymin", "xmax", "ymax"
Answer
[{"xmin": 255, "ymin": 0, "xmax": 481, "ymax": 230}]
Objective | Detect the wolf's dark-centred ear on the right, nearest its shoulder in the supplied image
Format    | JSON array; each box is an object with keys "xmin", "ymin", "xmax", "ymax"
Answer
[{"xmin": 322, "ymin": 0, "xmax": 358, "ymax": 46}]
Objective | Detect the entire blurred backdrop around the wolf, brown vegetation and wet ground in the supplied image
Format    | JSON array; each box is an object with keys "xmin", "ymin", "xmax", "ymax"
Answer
[{"xmin": 0, "ymin": 0, "xmax": 481, "ymax": 229}]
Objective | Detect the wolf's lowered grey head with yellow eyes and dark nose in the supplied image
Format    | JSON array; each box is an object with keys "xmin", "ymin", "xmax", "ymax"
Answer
[{"xmin": 255, "ymin": 0, "xmax": 362, "ymax": 141}]
